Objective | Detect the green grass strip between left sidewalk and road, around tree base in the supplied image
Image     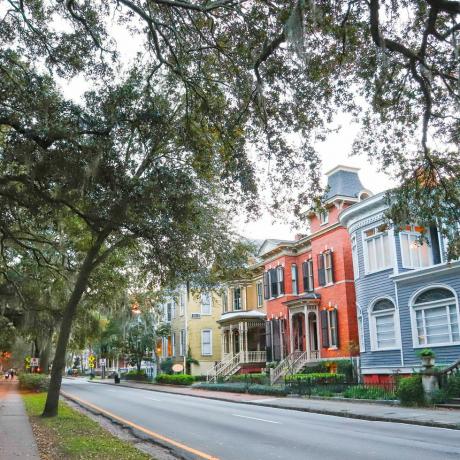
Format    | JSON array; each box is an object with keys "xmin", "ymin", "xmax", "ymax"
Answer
[{"xmin": 22, "ymin": 393, "xmax": 151, "ymax": 460}]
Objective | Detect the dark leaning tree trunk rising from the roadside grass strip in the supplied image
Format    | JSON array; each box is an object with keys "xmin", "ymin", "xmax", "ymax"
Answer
[{"xmin": 42, "ymin": 232, "xmax": 109, "ymax": 417}]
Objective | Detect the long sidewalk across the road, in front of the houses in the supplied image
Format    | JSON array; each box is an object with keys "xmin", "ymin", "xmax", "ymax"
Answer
[{"xmin": 87, "ymin": 379, "xmax": 460, "ymax": 430}]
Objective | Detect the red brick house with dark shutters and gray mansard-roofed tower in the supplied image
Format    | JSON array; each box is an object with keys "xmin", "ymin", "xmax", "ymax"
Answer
[{"xmin": 259, "ymin": 166, "xmax": 370, "ymax": 381}]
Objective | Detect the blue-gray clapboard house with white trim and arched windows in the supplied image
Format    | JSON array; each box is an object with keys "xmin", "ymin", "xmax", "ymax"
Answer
[{"xmin": 340, "ymin": 193, "xmax": 460, "ymax": 382}]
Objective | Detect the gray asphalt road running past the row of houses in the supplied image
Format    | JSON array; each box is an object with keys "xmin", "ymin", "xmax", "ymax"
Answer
[{"xmin": 62, "ymin": 380, "xmax": 460, "ymax": 460}]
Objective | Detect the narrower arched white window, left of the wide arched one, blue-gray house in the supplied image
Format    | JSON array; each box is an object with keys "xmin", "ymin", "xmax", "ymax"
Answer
[{"xmin": 371, "ymin": 299, "xmax": 398, "ymax": 350}]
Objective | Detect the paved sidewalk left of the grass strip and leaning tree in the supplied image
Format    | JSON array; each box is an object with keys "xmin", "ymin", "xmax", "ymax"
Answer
[{"xmin": 0, "ymin": 380, "xmax": 40, "ymax": 460}]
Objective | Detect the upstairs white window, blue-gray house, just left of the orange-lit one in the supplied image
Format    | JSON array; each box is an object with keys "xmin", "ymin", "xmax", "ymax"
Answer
[{"xmin": 364, "ymin": 225, "xmax": 393, "ymax": 273}]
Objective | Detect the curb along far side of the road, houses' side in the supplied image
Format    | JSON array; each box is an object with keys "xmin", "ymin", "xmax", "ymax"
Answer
[{"xmin": 87, "ymin": 382, "xmax": 460, "ymax": 430}]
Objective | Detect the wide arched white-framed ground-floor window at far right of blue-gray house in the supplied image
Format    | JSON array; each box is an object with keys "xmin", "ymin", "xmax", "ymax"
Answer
[{"xmin": 413, "ymin": 287, "xmax": 460, "ymax": 346}]
